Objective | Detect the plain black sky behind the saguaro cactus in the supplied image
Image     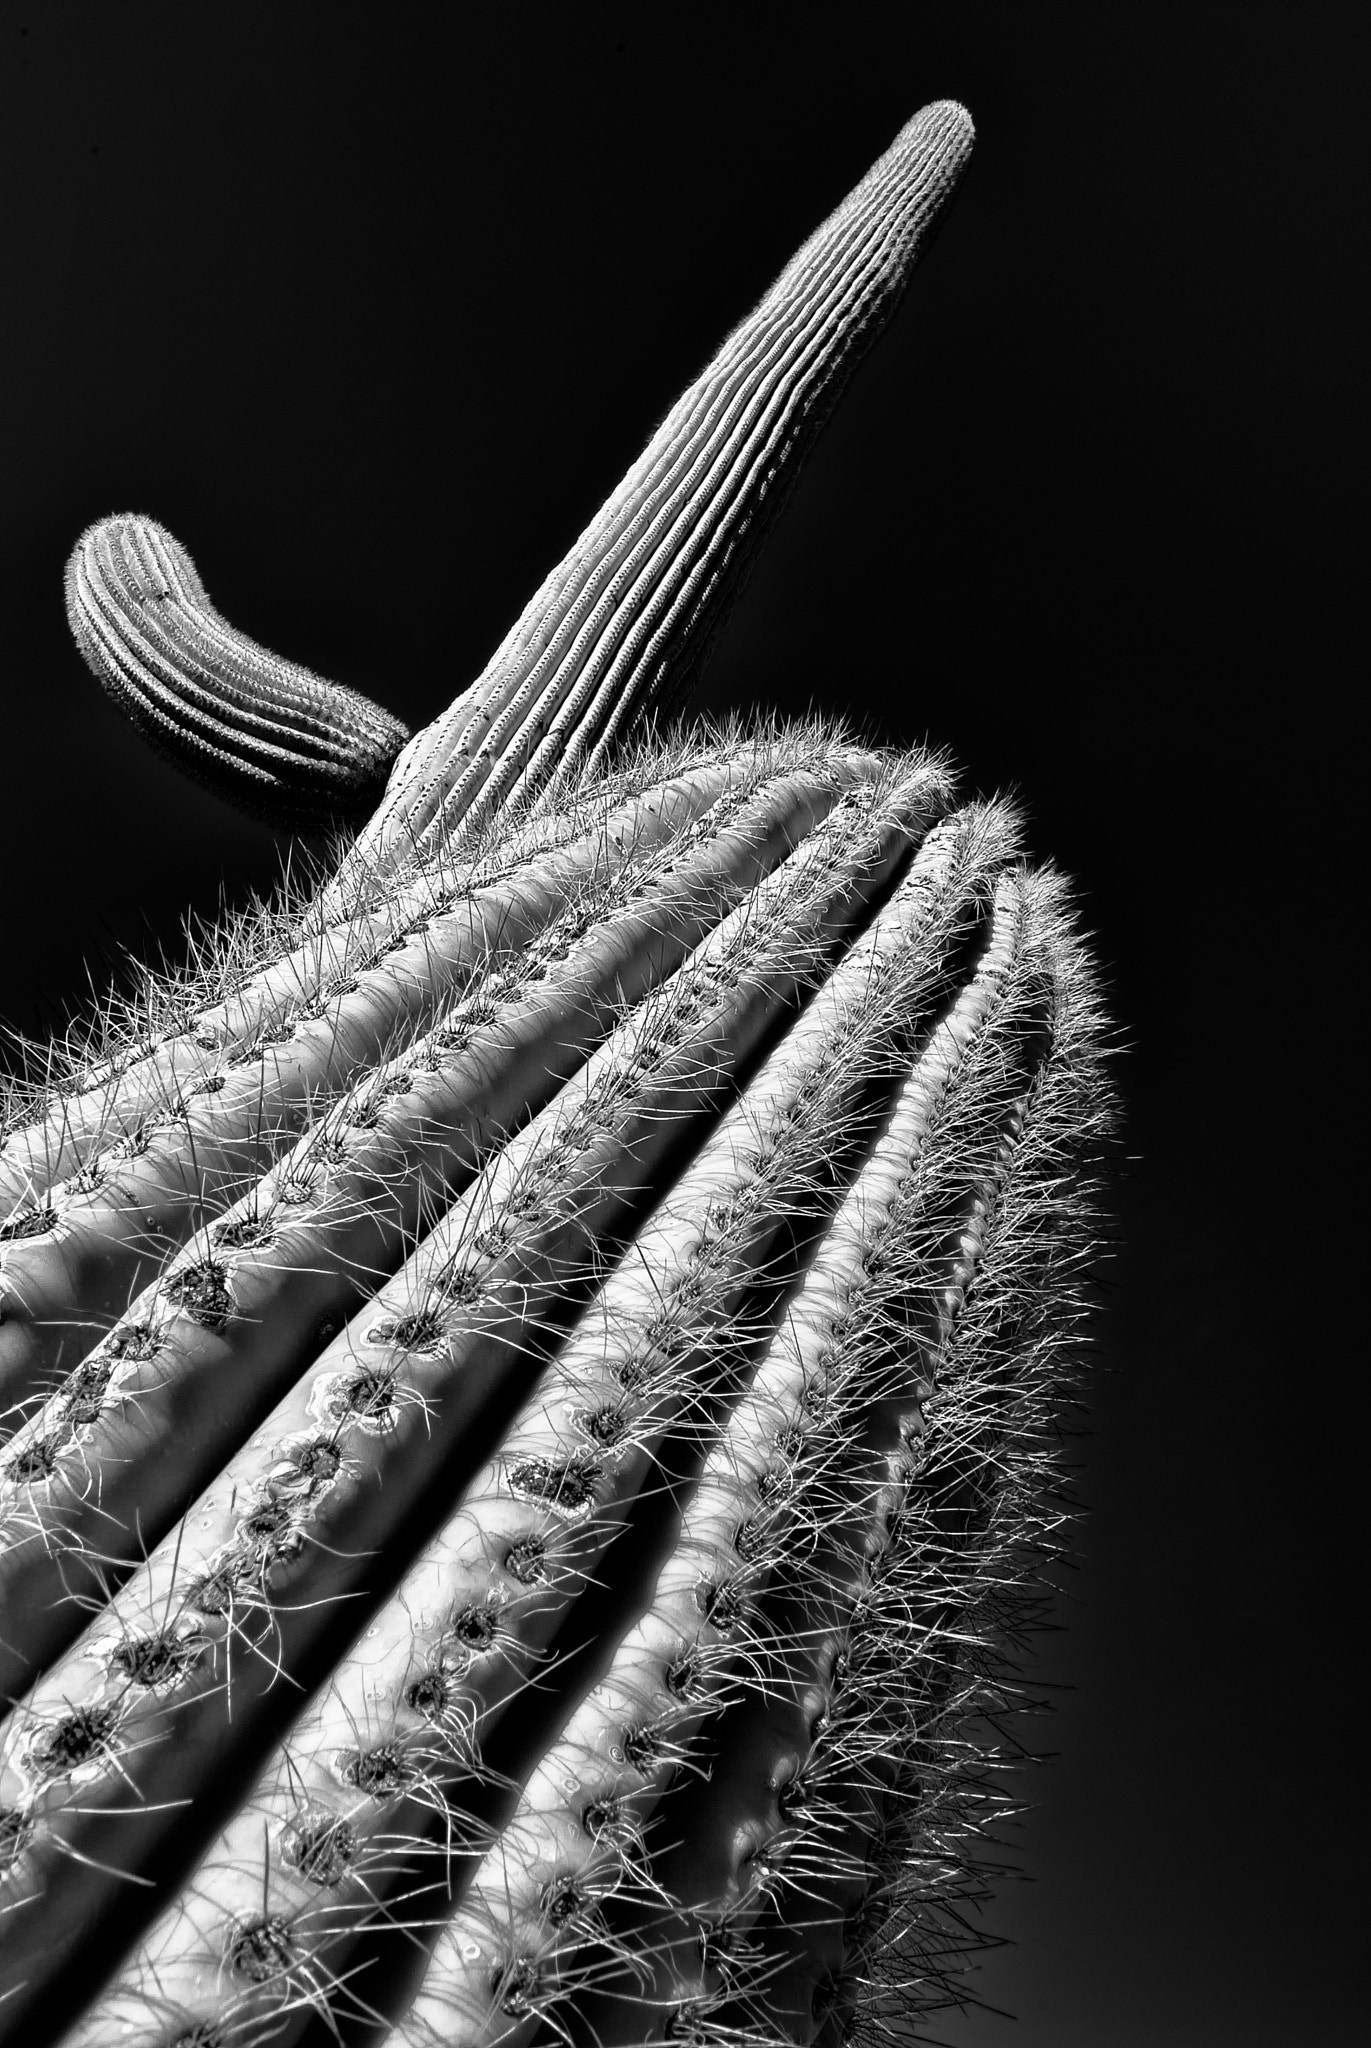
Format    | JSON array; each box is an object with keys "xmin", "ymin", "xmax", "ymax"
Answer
[{"xmin": 0, "ymin": 0, "xmax": 1367, "ymax": 2048}]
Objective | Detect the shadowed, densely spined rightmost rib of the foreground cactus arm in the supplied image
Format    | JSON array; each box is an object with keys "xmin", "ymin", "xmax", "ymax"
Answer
[{"xmin": 582, "ymin": 877, "xmax": 1098, "ymax": 2048}]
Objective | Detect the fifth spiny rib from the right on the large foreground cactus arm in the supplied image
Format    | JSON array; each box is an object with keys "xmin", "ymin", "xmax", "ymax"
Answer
[{"xmin": 0, "ymin": 764, "xmax": 909, "ymax": 1696}]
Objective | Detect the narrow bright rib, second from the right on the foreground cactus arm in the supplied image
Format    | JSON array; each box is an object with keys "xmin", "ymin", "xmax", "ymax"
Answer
[{"xmin": 383, "ymin": 877, "xmax": 1023, "ymax": 2048}]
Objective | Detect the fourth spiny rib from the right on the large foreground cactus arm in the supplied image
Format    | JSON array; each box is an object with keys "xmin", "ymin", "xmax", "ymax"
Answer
[{"xmin": 0, "ymin": 753, "xmax": 967, "ymax": 2011}]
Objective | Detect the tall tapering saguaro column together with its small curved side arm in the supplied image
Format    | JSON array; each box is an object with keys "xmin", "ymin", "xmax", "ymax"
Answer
[{"xmin": 56, "ymin": 100, "xmax": 973, "ymax": 905}]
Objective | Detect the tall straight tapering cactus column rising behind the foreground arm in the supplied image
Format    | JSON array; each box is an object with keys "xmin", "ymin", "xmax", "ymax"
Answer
[{"xmin": 325, "ymin": 100, "xmax": 973, "ymax": 913}]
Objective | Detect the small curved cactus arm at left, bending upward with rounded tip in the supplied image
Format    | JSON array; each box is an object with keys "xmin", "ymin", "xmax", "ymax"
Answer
[{"xmin": 66, "ymin": 512, "xmax": 410, "ymax": 829}]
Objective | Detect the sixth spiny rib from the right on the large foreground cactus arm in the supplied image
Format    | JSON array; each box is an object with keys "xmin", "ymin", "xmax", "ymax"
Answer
[{"xmin": 0, "ymin": 762, "xmax": 791, "ymax": 1430}]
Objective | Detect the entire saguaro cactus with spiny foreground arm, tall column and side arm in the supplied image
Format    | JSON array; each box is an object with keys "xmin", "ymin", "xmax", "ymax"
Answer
[{"xmin": 0, "ymin": 104, "xmax": 1109, "ymax": 2048}]
